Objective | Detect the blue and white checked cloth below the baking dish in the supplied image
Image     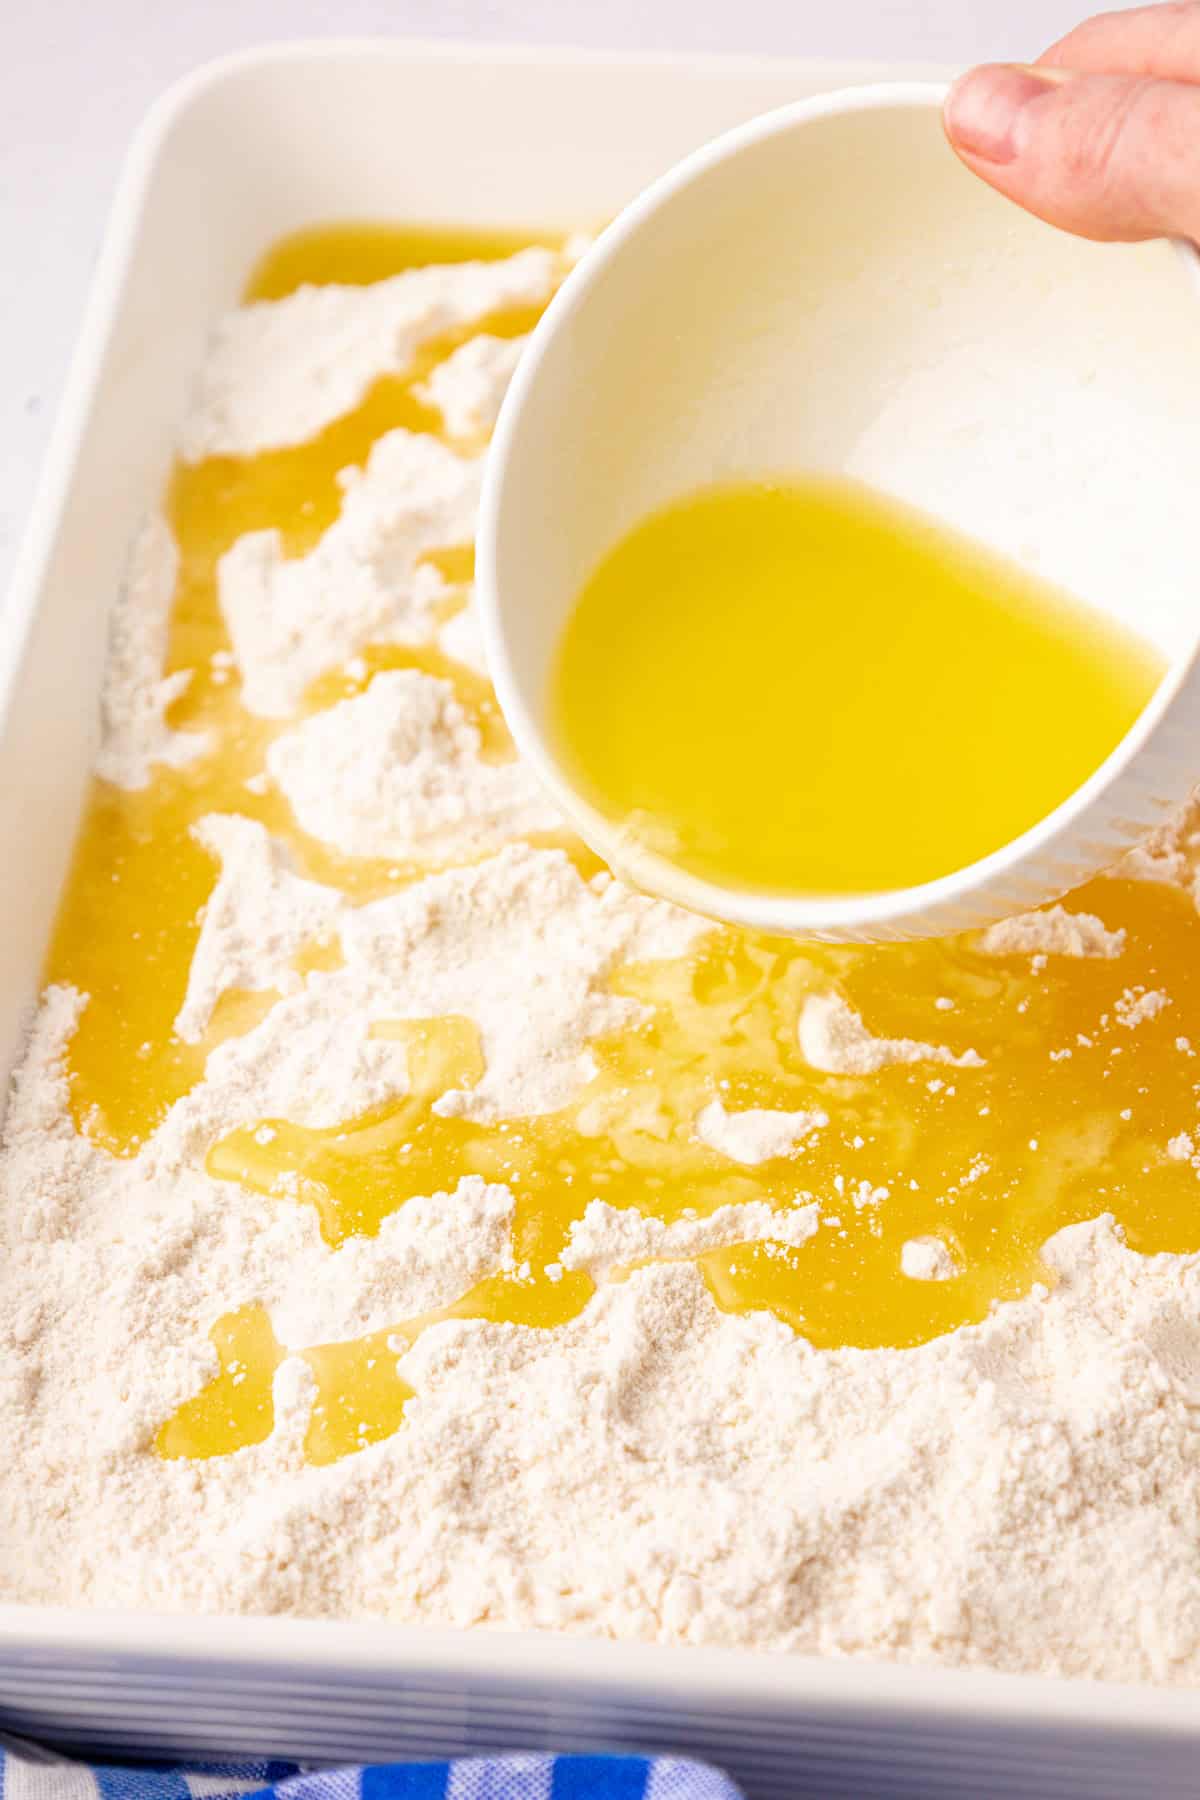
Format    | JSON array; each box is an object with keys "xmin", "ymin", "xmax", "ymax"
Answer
[{"xmin": 0, "ymin": 1737, "xmax": 741, "ymax": 1800}]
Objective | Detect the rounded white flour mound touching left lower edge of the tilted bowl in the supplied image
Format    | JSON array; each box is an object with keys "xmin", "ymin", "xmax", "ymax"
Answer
[{"xmin": 266, "ymin": 670, "xmax": 561, "ymax": 862}]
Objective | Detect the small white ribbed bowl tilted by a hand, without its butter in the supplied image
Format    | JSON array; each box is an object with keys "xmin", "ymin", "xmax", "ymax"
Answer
[{"xmin": 479, "ymin": 83, "xmax": 1200, "ymax": 941}]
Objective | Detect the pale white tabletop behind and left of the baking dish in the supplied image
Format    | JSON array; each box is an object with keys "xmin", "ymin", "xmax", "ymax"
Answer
[{"xmin": 0, "ymin": 0, "xmax": 1087, "ymax": 594}]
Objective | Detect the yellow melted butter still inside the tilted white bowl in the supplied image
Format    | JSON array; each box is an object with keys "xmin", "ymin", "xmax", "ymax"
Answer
[{"xmin": 551, "ymin": 477, "xmax": 1162, "ymax": 896}]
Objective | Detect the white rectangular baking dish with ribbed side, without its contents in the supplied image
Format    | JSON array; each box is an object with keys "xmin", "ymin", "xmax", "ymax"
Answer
[{"xmin": 0, "ymin": 41, "xmax": 1200, "ymax": 1800}]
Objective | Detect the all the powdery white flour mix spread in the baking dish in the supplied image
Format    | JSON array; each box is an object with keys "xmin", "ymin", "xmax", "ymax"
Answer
[{"xmin": 0, "ymin": 252, "xmax": 1200, "ymax": 1683}]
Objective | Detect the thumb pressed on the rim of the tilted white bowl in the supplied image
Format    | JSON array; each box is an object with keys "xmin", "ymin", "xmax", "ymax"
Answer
[{"xmin": 945, "ymin": 63, "xmax": 1200, "ymax": 239}]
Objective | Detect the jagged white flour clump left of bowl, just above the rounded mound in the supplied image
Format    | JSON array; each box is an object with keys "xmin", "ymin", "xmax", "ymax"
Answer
[{"xmin": 218, "ymin": 430, "xmax": 482, "ymax": 718}]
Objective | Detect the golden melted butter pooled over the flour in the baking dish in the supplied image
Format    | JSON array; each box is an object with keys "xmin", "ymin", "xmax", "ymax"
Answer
[{"xmin": 35, "ymin": 221, "xmax": 1200, "ymax": 1462}]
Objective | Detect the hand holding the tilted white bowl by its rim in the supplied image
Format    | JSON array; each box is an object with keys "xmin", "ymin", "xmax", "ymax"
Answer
[{"xmin": 945, "ymin": 0, "xmax": 1200, "ymax": 239}]
